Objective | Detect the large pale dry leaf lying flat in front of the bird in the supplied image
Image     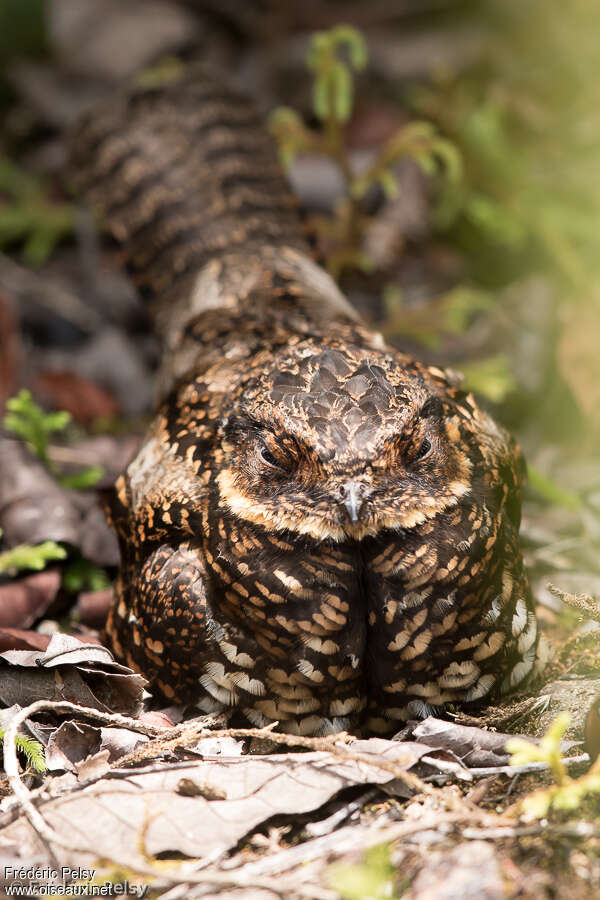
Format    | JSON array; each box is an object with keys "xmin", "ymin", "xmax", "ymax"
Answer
[{"xmin": 3, "ymin": 738, "xmax": 427, "ymax": 868}]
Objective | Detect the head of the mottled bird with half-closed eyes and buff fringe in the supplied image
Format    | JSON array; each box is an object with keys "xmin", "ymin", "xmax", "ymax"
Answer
[{"xmin": 217, "ymin": 344, "xmax": 482, "ymax": 541}]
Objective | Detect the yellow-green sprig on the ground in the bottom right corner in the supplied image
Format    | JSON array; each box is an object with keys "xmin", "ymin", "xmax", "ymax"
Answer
[{"xmin": 506, "ymin": 712, "xmax": 600, "ymax": 819}]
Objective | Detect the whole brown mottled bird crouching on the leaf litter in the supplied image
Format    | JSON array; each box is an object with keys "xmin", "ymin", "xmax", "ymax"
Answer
[{"xmin": 73, "ymin": 73, "xmax": 537, "ymax": 735}]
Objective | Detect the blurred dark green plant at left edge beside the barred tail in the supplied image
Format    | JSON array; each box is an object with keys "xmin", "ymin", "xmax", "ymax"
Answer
[{"xmin": 0, "ymin": 156, "xmax": 74, "ymax": 266}]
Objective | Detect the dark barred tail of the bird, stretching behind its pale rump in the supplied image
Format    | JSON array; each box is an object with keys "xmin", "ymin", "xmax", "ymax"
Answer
[{"xmin": 71, "ymin": 71, "xmax": 307, "ymax": 310}]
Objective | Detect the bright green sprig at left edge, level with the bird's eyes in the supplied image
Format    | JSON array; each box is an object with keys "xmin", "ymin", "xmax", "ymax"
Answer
[{"xmin": 4, "ymin": 389, "xmax": 104, "ymax": 490}]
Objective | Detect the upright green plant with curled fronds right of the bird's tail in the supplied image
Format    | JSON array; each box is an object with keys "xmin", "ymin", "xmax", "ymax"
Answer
[{"xmin": 270, "ymin": 25, "xmax": 461, "ymax": 275}]
